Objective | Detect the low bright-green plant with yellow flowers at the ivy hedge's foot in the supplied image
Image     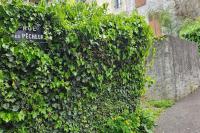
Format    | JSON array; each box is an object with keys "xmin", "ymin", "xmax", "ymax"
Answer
[{"xmin": 103, "ymin": 107, "xmax": 156, "ymax": 133}]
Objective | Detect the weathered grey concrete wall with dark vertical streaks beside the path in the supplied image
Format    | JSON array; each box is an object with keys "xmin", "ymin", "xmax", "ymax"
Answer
[{"xmin": 147, "ymin": 37, "xmax": 200, "ymax": 99}]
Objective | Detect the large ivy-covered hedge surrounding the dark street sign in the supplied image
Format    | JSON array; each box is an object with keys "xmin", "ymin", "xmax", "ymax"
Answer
[{"xmin": 0, "ymin": 0, "xmax": 152, "ymax": 133}]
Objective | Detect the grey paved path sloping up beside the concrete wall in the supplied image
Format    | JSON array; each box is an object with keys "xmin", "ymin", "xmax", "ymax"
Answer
[{"xmin": 155, "ymin": 90, "xmax": 200, "ymax": 133}]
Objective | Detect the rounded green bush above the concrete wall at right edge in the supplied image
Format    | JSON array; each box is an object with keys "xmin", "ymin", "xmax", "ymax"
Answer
[{"xmin": 179, "ymin": 20, "xmax": 200, "ymax": 46}]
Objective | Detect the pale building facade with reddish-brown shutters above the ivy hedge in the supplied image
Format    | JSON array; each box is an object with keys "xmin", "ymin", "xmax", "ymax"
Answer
[{"xmin": 25, "ymin": 0, "xmax": 175, "ymax": 36}]
